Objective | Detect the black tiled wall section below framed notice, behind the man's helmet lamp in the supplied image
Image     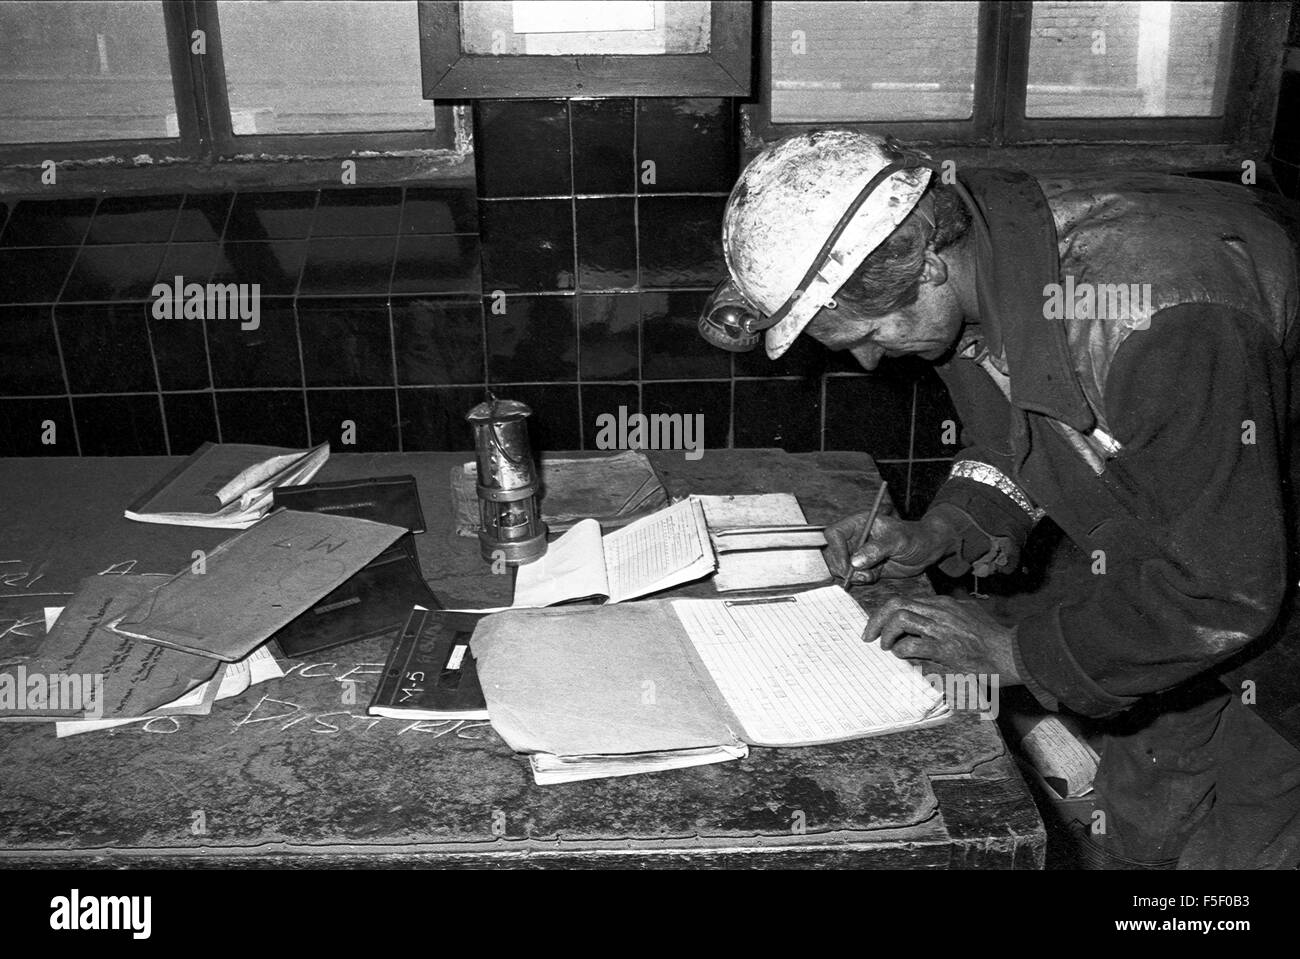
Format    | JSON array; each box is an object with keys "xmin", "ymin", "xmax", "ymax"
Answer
[{"xmin": 475, "ymin": 99, "xmax": 953, "ymax": 512}]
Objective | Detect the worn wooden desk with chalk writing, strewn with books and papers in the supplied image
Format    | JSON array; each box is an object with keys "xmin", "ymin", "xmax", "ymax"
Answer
[{"xmin": 0, "ymin": 450, "xmax": 1045, "ymax": 868}]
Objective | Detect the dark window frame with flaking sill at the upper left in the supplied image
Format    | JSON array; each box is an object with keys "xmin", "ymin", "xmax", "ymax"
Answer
[{"xmin": 0, "ymin": 0, "xmax": 473, "ymax": 194}]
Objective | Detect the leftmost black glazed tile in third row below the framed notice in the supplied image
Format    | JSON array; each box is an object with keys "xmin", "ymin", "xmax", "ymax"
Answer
[{"xmin": 484, "ymin": 296, "xmax": 577, "ymax": 383}]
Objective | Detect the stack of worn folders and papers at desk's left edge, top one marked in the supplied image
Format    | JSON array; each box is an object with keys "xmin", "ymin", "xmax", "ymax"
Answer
[{"xmin": 0, "ymin": 509, "xmax": 406, "ymax": 734}]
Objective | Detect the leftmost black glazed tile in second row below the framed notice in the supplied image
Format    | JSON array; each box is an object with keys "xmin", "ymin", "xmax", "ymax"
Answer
[{"xmin": 478, "ymin": 200, "xmax": 573, "ymax": 292}]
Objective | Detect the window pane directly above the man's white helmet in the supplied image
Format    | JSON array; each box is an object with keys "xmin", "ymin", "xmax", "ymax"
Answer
[{"xmin": 772, "ymin": 3, "xmax": 979, "ymax": 123}]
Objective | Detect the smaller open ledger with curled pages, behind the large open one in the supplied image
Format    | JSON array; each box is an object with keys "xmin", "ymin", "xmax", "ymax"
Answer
[{"xmin": 514, "ymin": 492, "xmax": 829, "ymax": 607}]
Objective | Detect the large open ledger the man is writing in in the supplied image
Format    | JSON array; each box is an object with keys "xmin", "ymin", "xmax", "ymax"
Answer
[{"xmin": 471, "ymin": 586, "xmax": 950, "ymax": 785}]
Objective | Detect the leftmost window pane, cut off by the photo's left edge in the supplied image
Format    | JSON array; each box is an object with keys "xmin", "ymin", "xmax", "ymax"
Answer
[{"xmin": 0, "ymin": 0, "xmax": 177, "ymax": 143}]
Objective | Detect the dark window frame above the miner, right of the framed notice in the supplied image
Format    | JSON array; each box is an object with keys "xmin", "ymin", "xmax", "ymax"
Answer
[{"xmin": 742, "ymin": 0, "xmax": 1290, "ymax": 160}]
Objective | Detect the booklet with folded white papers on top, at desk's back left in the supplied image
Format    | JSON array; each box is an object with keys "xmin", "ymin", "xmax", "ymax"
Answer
[{"xmin": 125, "ymin": 443, "xmax": 329, "ymax": 529}]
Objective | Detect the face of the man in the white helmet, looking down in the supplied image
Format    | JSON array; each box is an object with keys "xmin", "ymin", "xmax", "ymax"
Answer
[{"xmin": 803, "ymin": 272, "xmax": 963, "ymax": 369}]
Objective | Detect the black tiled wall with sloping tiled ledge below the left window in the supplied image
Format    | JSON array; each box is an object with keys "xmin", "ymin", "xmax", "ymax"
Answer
[{"xmin": 0, "ymin": 185, "xmax": 482, "ymax": 456}]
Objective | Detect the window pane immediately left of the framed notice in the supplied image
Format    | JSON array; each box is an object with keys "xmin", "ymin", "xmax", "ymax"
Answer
[{"xmin": 217, "ymin": 0, "xmax": 433, "ymax": 134}]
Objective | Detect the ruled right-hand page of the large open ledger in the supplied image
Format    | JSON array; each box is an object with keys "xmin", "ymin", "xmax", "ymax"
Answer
[{"xmin": 672, "ymin": 586, "xmax": 946, "ymax": 746}]
